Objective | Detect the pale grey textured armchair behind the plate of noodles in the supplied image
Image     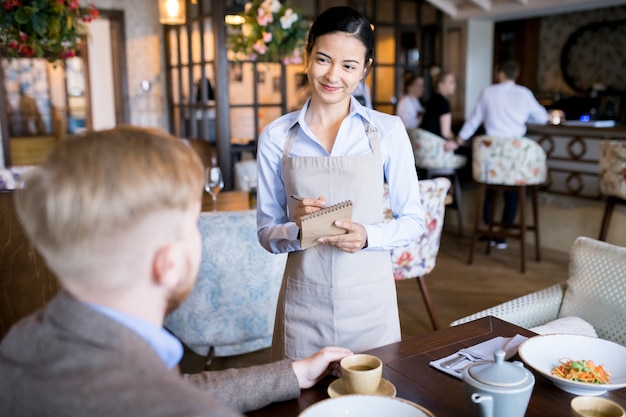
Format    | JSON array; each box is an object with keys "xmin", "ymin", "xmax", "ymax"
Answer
[{"xmin": 451, "ymin": 236, "xmax": 626, "ymax": 346}]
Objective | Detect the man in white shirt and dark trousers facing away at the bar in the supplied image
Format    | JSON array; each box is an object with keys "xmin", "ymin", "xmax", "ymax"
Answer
[{"xmin": 448, "ymin": 61, "xmax": 548, "ymax": 249}]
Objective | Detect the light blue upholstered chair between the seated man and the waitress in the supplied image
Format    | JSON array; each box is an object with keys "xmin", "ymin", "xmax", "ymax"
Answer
[{"xmin": 165, "ymin": 210, "xmax": 287, "ymax": 356}]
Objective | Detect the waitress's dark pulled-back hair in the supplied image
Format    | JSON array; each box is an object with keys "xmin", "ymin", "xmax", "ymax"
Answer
[{"xmin": 305, "ymin": 6, "xmax": 374, "ymax": 65}]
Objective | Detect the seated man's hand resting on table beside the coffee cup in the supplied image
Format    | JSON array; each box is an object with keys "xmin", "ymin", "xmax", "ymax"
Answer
[{"xmin": 293, "ymin": 346, "xmax": 352, "ymax": 388}]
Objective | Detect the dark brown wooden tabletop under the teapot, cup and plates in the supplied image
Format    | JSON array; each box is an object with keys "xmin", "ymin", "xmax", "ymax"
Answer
[{"xmin": 246, "ymin": 317, "xmax": 626, "ymax": 417}]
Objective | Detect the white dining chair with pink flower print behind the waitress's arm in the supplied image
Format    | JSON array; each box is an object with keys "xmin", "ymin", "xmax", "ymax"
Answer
[{"xmin": 383, "ymin": 177, "xmax": 451, "ymax": 330}]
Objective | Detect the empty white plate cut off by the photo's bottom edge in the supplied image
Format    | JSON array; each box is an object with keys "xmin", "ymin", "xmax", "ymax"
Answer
[{"xmin": 300, "ymin": 395, "xmax": 433, "ymax": 417}]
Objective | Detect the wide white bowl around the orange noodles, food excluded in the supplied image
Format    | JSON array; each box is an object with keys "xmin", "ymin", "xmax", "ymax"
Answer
[{"xmin": 518, "ymin": 334, "xmax": 626, "ymax": 395}]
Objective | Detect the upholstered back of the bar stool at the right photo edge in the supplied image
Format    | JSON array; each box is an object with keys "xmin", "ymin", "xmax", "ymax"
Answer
[{"xmin": 598, "ymin": 140, "xmax": 626, "ymax": 199}]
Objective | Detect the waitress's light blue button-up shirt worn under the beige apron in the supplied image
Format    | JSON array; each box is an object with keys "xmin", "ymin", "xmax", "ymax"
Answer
[{"xmin": 257, "ymin": 97, "xmax": 425, "ymax": 253}]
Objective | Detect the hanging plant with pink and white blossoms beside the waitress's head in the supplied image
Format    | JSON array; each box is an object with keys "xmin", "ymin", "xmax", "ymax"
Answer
[{"xmin": 227, "ymin": 0, "xmax": 309, "ymax": 64}]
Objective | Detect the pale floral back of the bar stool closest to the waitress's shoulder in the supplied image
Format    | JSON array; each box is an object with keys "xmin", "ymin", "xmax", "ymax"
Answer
[{"xmin": 407, "ymin": 128, "xmax": 467, "ymax": 169}]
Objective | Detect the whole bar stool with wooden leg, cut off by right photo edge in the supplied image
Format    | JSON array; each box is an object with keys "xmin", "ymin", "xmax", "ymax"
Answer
[{"xmin": 598, "ymin": 140, "xmax": 626, "ymax": 241}]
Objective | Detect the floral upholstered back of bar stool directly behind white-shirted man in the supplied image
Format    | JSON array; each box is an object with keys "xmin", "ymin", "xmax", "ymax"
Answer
[{"xmin": 472, "ymin": 136, "xmax": 548, "ymax": 185}]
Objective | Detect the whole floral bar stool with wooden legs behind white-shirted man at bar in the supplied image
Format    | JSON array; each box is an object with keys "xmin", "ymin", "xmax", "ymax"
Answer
[{"xmin": 467, "ymin": 136, "xmax": 547, "ymax": 273}]
